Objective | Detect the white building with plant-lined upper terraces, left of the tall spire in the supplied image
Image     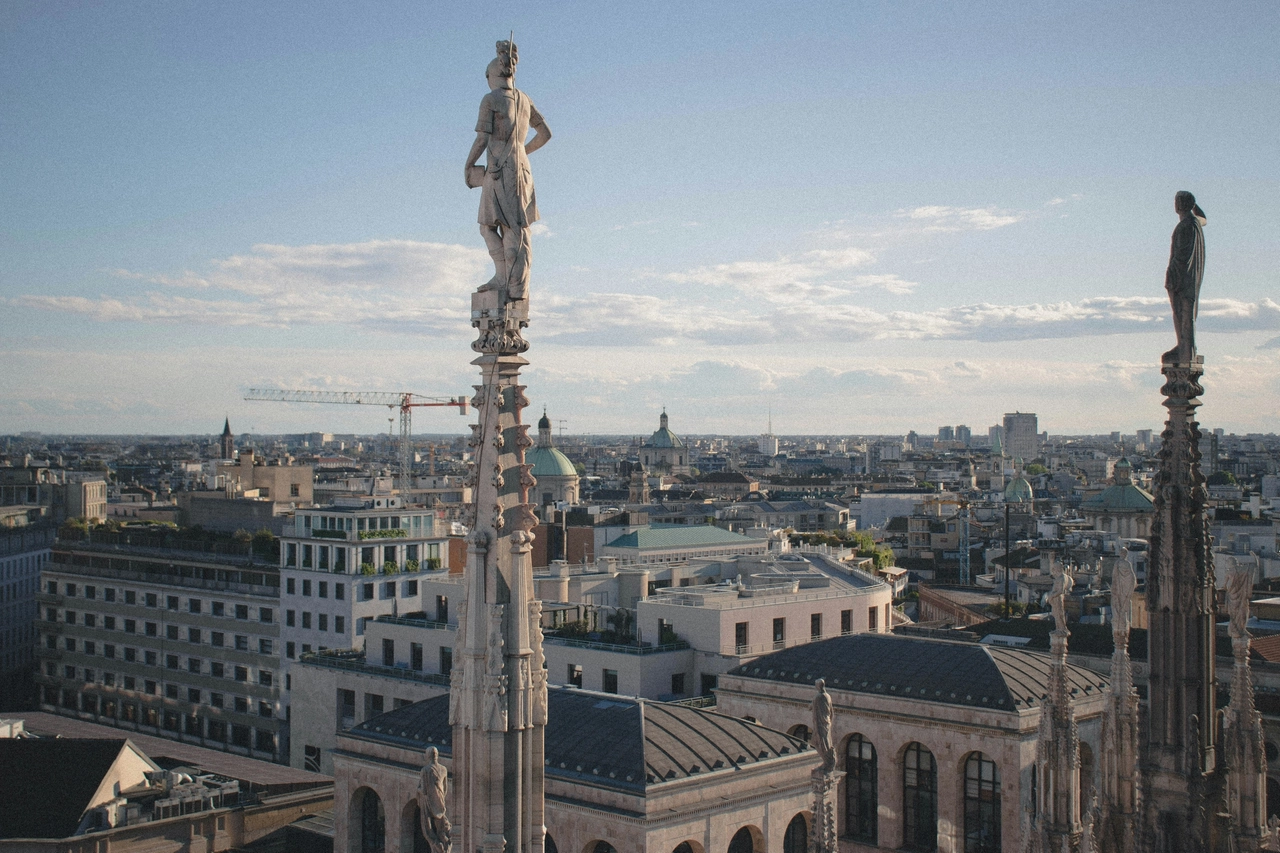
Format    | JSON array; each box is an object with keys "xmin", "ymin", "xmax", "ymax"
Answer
[{"xmin": 280, "ymin": 496, "xmax": 462, "ymax": 704}]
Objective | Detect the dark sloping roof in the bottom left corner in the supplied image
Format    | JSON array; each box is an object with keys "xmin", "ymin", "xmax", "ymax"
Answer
[{"xmin": 0, "ymin": 738, "xmax": 128, "ymax": 838}]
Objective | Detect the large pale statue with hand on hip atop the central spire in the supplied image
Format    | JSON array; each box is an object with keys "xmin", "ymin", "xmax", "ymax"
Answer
[{"xmin": 463, "ymin": 41, "xmax": 552, "ymax": 302}]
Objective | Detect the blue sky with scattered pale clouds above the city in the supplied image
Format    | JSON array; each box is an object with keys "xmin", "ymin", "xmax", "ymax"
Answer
[{"xmin": 0, "ymin": 0, "xmax": 1280, "ymax": 434}]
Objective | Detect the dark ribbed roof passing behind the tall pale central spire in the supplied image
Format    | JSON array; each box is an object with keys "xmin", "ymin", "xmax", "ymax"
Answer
[{"xmin": 348, "ymin": 688, "xmax": 810, "ymax": 793}]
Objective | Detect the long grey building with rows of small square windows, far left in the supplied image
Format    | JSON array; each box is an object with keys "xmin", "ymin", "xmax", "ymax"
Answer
[{"xmin": 36, "ymin": 544, "xmax": 288, "ymax": 761}]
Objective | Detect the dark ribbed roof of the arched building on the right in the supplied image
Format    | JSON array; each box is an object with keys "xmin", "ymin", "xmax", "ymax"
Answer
[{"xmin": 728, "ymin": 634, "xmax": 1107, "ymax": 712}]
